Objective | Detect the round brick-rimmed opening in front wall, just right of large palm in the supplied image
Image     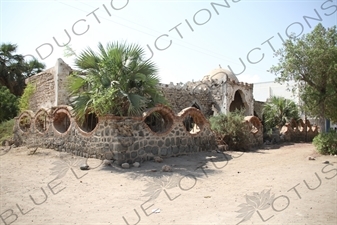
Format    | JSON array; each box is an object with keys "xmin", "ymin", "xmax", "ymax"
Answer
[{"xmin": 144, "ymin": 111, "xmax": 173, "ymax": 133}]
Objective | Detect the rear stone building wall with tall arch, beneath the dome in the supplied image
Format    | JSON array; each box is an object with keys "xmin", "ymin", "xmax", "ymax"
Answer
[{"xmin": 160, "ymin": 78, "xmax": 254, "ymax": 117}]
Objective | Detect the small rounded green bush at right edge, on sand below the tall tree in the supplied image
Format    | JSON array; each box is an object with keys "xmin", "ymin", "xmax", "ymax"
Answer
[{"xmin": 312, "ymin": 130, "xmax": 337, "ymax": 155}]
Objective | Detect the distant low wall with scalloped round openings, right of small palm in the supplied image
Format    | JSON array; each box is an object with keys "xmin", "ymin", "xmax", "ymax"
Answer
[{"xmin": 280, "ymin": 119, "xmax": 318, "ymax": 142}]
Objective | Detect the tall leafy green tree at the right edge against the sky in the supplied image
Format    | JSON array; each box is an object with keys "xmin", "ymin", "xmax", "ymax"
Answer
[{"xmin": 271, "ymin": 24, "xmax": 337, "ymax": 121}]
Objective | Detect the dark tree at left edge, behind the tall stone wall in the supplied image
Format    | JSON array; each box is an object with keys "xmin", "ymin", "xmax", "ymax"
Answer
[{"xmin": 0, "ymin": 44, "xmax": 45, "ymax": 96}]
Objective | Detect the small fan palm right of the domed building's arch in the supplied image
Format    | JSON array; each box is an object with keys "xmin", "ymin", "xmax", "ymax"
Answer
[{"xmin": 262, "ymin": 96, "xmax": 299, "ymax": 131}]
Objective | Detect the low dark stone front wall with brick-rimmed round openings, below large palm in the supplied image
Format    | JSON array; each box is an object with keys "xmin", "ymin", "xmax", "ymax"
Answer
[{"xmin": 14, "ymin": 106, "xmax": 217, "ymax": 163}]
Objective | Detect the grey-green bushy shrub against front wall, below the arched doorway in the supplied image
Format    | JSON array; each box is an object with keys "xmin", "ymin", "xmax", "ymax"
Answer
[{"xmin": 209, "ymin": 110, "xmax": 249, "ymax": 150}]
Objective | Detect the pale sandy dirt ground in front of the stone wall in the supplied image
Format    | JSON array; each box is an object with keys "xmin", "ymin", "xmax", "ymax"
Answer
[{"xmin": 0, "ymin": 143, "xmax": 337, "ymax": 225}]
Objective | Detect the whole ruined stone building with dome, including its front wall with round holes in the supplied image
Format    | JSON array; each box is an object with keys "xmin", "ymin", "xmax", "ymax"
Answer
[{"xmin": 14, "ymin": 59, "xmax": 263, "ymax": 163}]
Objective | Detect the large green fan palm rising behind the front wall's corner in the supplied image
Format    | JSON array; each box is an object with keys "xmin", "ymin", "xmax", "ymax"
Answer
[{"xmin": 69, "ymin": 42, "xmax": 166, "ymax": 121}]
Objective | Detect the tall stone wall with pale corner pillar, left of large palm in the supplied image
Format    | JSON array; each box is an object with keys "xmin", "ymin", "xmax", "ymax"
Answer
[{"xmin": 26, "ymin": 59, "xmax": 72, "ymax": 111}]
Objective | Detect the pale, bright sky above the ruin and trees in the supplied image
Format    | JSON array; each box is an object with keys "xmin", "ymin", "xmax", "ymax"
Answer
[{"xmin": 0, "ymin": 0, "xmax": 337, "ymax": 83}]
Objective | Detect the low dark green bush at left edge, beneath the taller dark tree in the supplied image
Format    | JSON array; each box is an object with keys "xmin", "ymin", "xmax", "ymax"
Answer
[{"xmin": 0, "ymin": 85, "xmax": 19, "ymax": 123}]
